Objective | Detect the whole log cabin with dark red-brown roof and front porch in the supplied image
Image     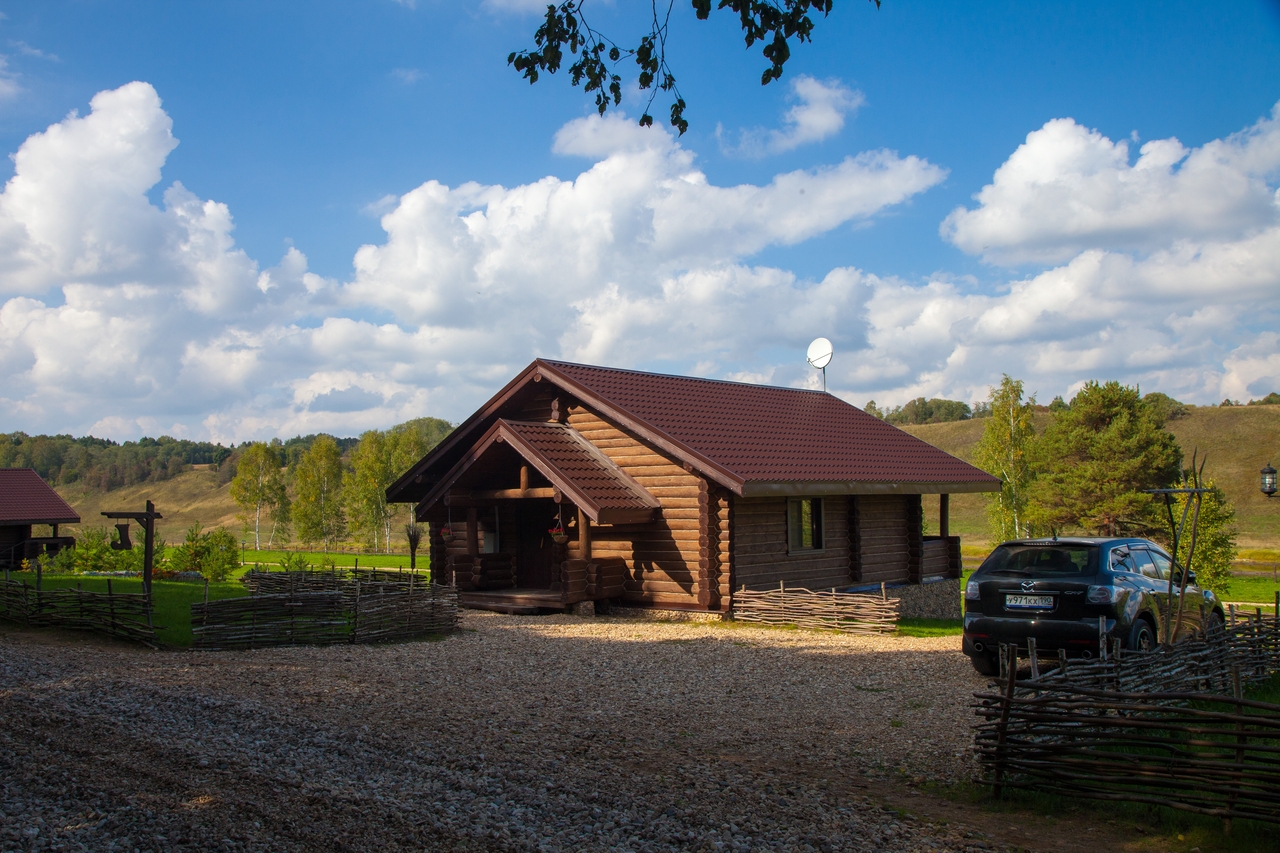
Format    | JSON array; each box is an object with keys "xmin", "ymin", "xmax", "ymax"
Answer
[{"xmin": 387, "ymin": 359, "xmax": 1000, "ymax": 612}]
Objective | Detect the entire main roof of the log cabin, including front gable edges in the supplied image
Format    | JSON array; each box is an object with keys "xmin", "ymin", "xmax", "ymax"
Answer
[{"xmin": 388, "ymin": 359, "xmax": 1000, "ymax": 501}]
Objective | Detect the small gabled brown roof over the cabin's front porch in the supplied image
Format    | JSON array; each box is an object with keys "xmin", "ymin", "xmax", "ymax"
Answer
[{"xmin": 421, "ymin": 419, "xmax": 659, "ymax": 524}]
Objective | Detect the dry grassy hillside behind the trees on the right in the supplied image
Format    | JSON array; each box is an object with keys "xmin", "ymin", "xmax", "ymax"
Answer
[{"xmin": 902, "ymin": 406, "xmax": 1280, "ymax": 548}]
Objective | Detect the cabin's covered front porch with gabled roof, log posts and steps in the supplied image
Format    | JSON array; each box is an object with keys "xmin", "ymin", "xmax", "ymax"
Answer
[{"xmin": 417, "ymin": 419, "xmax": 659, "ymax": 613}]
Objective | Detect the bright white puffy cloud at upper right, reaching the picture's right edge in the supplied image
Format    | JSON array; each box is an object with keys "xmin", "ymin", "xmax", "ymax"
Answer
[{"xmin": 942, "ymin": 104, "xmax": 1280, "ymax": 264}]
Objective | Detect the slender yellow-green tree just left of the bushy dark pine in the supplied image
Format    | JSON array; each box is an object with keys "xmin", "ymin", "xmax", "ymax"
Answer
[{"xmin": 974, "ymin": 374, "xmax": 1036, "ymax": 539}]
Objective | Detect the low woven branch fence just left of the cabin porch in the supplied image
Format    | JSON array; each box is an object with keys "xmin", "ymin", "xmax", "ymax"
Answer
[{"xmin": 191, "ymin": 571, "xmax": 458, "ymax": 649}]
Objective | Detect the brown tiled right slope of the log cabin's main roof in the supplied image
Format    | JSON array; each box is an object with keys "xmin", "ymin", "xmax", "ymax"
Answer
[{"xmin": 541, "ymin": 361, "xmax": 1000, "ymax": 493}]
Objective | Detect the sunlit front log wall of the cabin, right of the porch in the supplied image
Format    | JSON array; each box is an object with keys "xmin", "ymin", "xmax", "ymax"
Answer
[{"xmin": 568, "ymin": 406, "xmax": 706, "ymax": 607}]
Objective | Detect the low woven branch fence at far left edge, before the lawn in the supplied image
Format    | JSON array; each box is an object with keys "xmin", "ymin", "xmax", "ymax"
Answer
[{"xmin": 0, "ymin": 580, "xmax": 157, "ymax": 647}]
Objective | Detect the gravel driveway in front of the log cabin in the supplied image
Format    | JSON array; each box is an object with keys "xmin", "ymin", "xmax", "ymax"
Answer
[{"xmin": 0, "ymin": 612, "xmax": 992, "ymax": 852}]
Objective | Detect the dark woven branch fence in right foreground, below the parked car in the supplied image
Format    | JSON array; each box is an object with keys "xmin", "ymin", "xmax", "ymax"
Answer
[{"xmin": 974, "ymin": 616, "xmax": 1280, "ymax": 829}]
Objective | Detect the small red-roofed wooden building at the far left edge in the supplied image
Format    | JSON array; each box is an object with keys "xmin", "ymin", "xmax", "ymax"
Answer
[{"xmin": 0, "ymin": 467, "xmax": 79, "ymax": 569}]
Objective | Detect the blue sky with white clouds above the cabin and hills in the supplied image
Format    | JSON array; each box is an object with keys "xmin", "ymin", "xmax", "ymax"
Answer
[{"xmin": 0, "ymin": 0, "xmax": 1280, "ymax": 439}]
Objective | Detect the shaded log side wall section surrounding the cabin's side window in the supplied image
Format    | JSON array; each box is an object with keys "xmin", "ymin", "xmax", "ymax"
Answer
[{"xmin": 733, "ymin": 496, "xmax": 852, "ymax": 589}]
